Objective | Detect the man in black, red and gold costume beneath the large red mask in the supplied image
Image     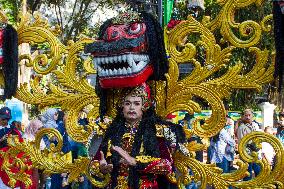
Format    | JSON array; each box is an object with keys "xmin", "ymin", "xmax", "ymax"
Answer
[{"xmin": 97, "ymin": 83, "xmax": 185, "ymax": 189}]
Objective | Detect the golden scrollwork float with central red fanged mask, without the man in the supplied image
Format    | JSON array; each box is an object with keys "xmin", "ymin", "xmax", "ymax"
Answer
[{"xmin": 1, "ymin": 0, "xmax": 284, "ymax": 188}]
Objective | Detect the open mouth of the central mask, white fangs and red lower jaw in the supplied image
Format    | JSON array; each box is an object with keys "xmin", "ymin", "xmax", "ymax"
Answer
[{"xmin": 94, "ymin": 53, "xmax": 153, "ymax": 88}]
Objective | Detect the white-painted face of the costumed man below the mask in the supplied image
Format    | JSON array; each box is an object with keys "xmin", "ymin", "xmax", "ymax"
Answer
[{"xmin": 123, "ymin": 95, "xmax": 143, "ymax": 123}]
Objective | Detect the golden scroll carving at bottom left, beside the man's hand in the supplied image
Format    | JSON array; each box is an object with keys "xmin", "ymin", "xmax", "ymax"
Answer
[{"xmin": 6, "ymin": 129, "xmax": 110, "ymax": 187}]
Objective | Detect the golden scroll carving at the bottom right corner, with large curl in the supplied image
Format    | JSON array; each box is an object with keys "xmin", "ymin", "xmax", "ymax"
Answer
[{"xmin": 170, "ymin": 132, "xmax": 284, "ymax": 188}]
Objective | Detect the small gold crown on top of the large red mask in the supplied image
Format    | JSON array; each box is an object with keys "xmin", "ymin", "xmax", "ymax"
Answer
[{"xmin": 112, "ymin": 10, "xmax": 141, "ymax": 24}]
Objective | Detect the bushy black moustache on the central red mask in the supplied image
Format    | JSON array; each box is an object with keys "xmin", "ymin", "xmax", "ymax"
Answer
[{"xmin": 84, "ymin": 35, "xmax": 145, "ymax": 53}]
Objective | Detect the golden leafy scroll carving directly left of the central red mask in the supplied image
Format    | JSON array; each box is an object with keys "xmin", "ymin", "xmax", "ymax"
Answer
[{"xmin": 16, "ymin": 12, "xmax": 99, "ymax": 142}]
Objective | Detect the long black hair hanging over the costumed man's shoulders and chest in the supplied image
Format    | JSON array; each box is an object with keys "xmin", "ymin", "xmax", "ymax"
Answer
[{"xmin": 101, "ymin": 107, "xmax": 186, "ymax": 189}]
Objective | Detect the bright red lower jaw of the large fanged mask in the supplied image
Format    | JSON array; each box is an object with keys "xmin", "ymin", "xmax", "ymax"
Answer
[{"xmin": 100, "ymin": 66, "xmax": 153, "ymax": 88}]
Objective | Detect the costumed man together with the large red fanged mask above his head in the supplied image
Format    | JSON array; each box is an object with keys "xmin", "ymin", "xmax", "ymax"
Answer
[{"xmin": 85, "ymin": 8, "xmax": 189, "ymax": 189}]
